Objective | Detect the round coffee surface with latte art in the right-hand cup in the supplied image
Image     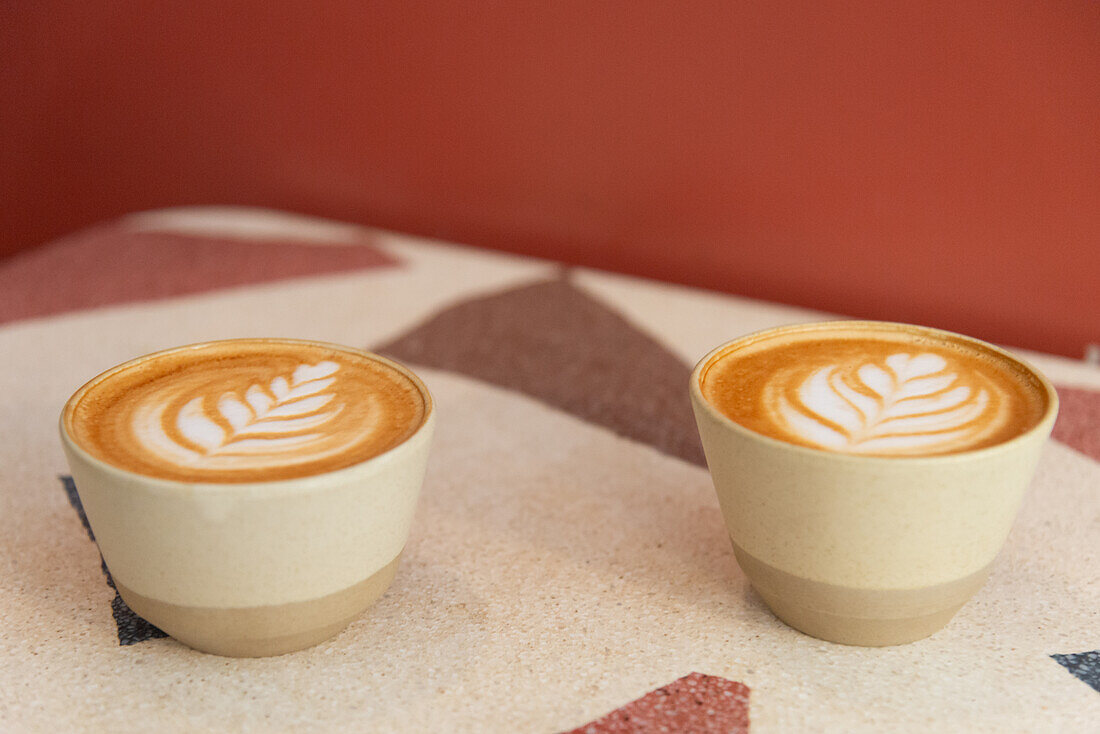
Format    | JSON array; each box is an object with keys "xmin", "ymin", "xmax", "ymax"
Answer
[{"xmin": 700, "ymin": 326, "xmax": 1046, "ymax": 456}]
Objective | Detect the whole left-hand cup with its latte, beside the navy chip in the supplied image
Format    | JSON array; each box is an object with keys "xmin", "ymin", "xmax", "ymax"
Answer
[{"xmin": 61, "ymin": 339, "xmax": 435, "ymax": 657}]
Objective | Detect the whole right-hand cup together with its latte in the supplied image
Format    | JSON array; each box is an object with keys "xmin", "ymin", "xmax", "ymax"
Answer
[{"xmin": 690, "ymin": 321, "xmax": 1058, "ymax": 646}]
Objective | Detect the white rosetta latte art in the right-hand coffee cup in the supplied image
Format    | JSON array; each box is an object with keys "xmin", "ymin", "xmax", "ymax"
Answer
[{"xmin": 763, "ymin": 353, "xmax": 1007, "ymax": 454}]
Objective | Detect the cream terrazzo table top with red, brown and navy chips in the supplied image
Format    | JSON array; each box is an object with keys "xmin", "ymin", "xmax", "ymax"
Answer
[{"xmin": 0, "ymin": 208, "xmax": 1100, "ymax": 733}]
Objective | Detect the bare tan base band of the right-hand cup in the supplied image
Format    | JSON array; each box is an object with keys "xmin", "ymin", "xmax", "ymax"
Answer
[{"xmin": 734, "ymin": 543, "xmax": 992, "ymax": 647}]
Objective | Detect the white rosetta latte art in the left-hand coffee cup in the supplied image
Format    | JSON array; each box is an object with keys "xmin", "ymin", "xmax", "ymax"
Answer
[{"xmin": 132, "ymin": 361, "xmax": 374, "ymax": 469}]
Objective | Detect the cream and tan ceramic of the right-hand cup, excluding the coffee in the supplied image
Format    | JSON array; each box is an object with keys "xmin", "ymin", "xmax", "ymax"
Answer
[{"xmin": 690, "ymin": 321, "xmax": 1058, "ymax": 646}]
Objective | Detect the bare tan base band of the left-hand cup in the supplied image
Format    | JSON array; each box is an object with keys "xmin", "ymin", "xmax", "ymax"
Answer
[{"xmin": 116, "ymin": 554, "xmax": 400, "ymax": 657}]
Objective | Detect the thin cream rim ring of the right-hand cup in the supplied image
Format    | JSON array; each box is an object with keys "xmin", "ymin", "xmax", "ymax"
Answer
[{"xmin": 689, "ymin": 319, "xmax": 1058, "ymax": 464}]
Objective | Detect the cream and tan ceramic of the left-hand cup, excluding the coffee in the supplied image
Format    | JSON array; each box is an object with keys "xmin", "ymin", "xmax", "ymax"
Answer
[{"xmin": 61, "ymin": 342, "xmax": 435, "ymax": 657}]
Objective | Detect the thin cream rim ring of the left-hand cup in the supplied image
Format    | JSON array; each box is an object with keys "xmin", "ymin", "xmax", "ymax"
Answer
[{"xmin": 58, "ymin": 337, "xmax": 436, "ymax": 492}]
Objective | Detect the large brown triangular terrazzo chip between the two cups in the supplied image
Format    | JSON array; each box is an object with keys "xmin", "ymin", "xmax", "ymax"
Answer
[{"xmin": 376, "ymin": 278, "xmax": 706, "ymax": 465}]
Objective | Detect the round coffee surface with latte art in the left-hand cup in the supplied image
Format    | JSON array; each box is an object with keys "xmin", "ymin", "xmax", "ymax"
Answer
[{"xmin": 65, "ymin": 340, "xmax": 427, "ymax": 482}]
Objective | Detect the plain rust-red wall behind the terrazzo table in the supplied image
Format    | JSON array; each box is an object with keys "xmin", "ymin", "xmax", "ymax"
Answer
[{"xmin": 0, "ymin": 0, "xmax": 1100, "ymax": 357}]
